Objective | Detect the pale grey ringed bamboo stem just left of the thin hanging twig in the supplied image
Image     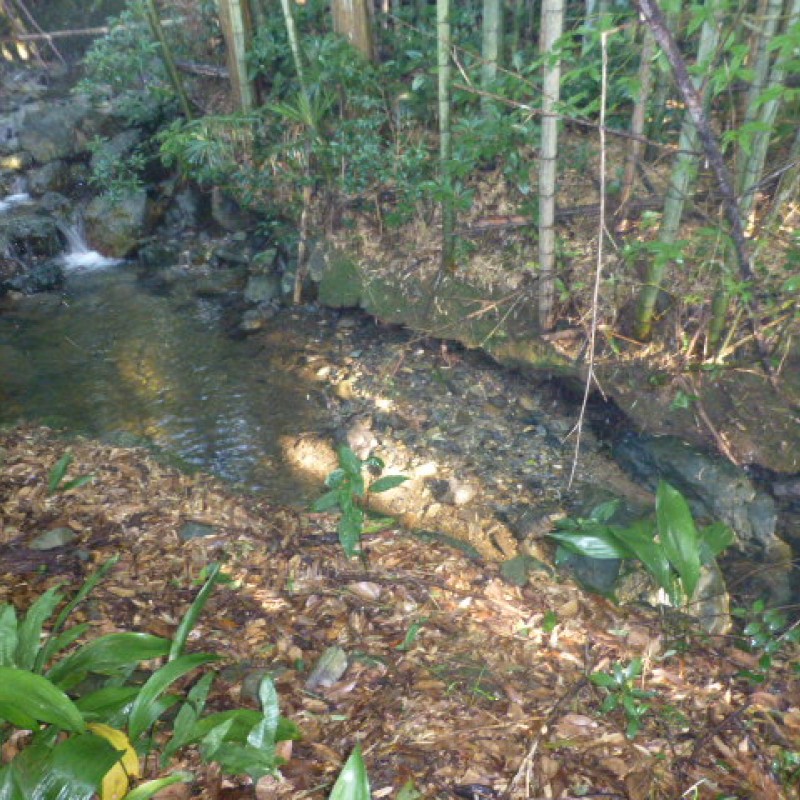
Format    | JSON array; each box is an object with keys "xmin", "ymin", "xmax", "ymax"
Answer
[{"xmin": 539, "ymin": 0, "xmax": 564, "ymax": 330}]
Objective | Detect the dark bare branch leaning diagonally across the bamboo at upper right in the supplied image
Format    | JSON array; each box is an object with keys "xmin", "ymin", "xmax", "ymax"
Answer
[{"xmin": 635, "ymin": 0, "xmax": 778, "ymax": 391}]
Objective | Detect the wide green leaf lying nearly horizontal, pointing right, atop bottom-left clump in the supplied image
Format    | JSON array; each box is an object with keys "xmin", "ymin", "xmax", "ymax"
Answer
[{"xmin": 47, "ymin": 633, "xmax": 170, "ymax": 688}]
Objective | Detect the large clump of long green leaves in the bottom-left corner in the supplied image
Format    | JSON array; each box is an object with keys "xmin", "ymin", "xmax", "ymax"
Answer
[{"xmin": 0, "ymin": 560, "xmax": 299, "ymax": 800}]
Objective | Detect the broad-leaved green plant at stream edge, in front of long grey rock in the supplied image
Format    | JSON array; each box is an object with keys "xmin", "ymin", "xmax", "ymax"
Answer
[{"xmin": 550, "ymin": 481, "xmax": 734, "ymax": 606}]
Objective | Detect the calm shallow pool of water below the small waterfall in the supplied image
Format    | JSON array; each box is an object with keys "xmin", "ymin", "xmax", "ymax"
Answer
[{"xmin": 0, "ymin": 266, "xmax": 324, "ymax": 502}]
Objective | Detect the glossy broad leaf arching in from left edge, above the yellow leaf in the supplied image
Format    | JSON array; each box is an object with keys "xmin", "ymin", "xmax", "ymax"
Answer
[{"xmin": 0, "ymin": 667, "xmax": 86, "ymax": 732}]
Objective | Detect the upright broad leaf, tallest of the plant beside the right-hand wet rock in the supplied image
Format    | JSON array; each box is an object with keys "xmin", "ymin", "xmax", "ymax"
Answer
[{"xmin": 656, "ymin": 481, "xmax": 700, "ymax": 598}]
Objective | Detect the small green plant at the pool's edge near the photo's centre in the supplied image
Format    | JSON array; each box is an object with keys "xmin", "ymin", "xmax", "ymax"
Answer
[{"xmin": 312, "ymin": 445, "xmax": 408, "ymax": 558}]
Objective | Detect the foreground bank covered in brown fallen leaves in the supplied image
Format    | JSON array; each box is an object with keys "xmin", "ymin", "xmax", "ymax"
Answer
[{"xmin": 0, "ymin": 428, "xmax": 800, "ymax": 800}]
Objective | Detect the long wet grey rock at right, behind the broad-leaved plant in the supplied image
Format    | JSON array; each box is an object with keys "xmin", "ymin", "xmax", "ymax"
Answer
[{"xmin": 613, "ymin": 434, "xmax": 779, "ymax": 558}]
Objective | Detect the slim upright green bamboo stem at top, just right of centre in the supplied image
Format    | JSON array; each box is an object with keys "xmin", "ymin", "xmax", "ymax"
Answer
[{"xmin": 436, "ymin": 0, "xmax": 455, "ymax": 271}]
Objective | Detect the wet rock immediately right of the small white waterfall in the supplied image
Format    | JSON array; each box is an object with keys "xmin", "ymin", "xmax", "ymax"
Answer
[{"xmin": 84, "ymin": 189, "xmax": 147, "ymax": 258}]
